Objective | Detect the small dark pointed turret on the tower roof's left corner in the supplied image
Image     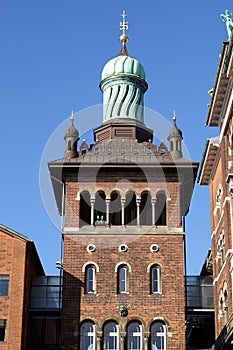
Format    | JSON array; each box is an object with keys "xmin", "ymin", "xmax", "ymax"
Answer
[{"xmin": 64, "ymin": 111, "xmax": 79, "ymax": 159}]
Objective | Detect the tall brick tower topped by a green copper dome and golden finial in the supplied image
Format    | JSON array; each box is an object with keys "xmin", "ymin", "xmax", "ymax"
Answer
[{"xmin": 49, "ymin": 12, "xmax": 198, "ymax": 350}]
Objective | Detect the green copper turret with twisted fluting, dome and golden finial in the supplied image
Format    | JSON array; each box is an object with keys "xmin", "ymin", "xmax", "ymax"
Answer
[{"xmin": 100, "ymin": 11, "xmax": 148, "ymax": 123}]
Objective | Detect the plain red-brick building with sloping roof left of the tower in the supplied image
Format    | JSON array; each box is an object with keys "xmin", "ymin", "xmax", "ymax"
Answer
[{"xmin": 0, "ymin": 225, "xmax": 44, "ymax": 350}]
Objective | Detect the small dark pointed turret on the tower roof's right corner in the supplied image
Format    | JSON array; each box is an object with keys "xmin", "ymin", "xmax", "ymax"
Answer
[{"xmin": 167, "ymin": 111, "xmax": 183, "ymax": 159}]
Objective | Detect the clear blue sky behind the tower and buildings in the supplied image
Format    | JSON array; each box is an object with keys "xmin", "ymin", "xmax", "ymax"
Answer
[{"xmin": 0, "ymin": 0, "xmax": 233, "ymax": 274}]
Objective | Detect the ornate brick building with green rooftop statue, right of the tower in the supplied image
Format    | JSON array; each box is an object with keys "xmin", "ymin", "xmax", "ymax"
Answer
[{"xmin": 199, "ymin": 15, "xmax": 233, "ymax": 350}]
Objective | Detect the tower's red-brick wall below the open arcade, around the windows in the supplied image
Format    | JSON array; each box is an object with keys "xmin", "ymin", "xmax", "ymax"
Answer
[{"xmin": 62, "ymin": 233, "xmax": 185, "ymax": 350}]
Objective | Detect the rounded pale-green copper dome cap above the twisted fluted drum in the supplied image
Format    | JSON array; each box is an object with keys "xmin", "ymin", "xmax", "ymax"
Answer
[{"xmin": 102, "ymin": 56, "xmax": 146, "ymax": 80}]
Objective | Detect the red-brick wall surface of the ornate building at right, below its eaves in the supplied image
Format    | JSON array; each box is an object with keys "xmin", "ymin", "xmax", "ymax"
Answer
[{"xmin": 210, "ymin": 144, "xmax": 233, "ymax": 338}]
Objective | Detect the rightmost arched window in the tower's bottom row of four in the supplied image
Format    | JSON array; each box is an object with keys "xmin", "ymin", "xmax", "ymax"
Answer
[{"xmin": 150, "ymin": 322, "xmax": 166, "ymax": 350}]
